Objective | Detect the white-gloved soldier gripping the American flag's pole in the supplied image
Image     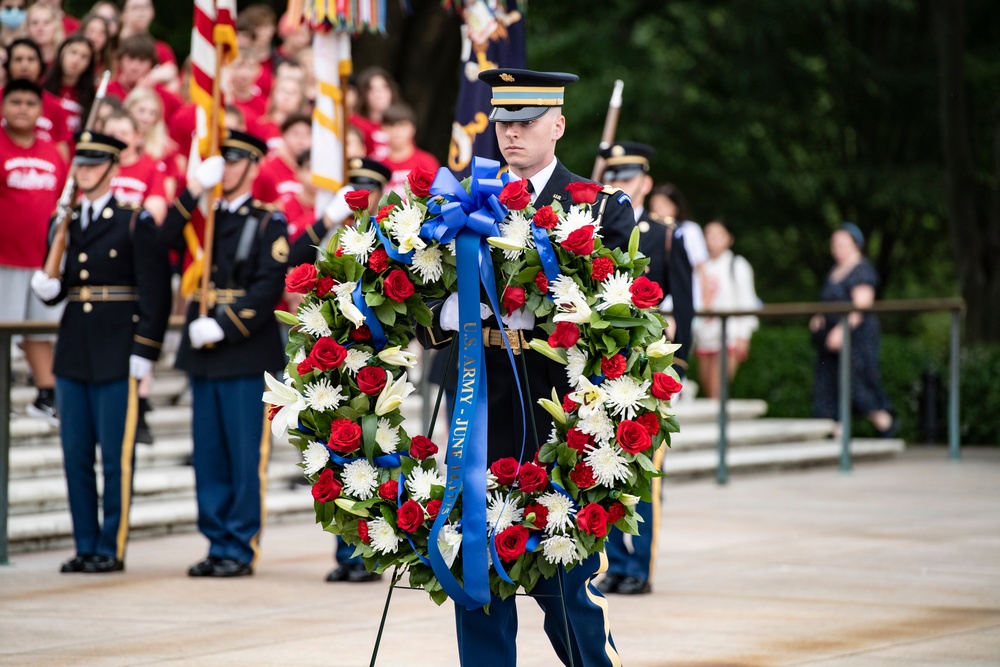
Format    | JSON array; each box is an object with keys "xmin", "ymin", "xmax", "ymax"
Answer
[{"xmin": 161, "ymin": 130, "xmax": 289, "ymax": 577}]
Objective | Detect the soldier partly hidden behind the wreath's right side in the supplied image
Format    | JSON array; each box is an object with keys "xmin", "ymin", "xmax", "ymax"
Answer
[{"xmin": 598, "ymin": 141, "xmax": 694, "ymax": 595}]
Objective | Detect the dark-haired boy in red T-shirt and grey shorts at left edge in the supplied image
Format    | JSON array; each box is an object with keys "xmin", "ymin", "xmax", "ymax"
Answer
[{"xmin": 0, "ymin": 79, "xmax": 66, "ymax": 420}]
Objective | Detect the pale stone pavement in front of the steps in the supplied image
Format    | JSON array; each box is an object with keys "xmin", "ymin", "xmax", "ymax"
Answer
[{"xmin": 0, "ymin": 448, "xmax": 1000, "ymax": 667}]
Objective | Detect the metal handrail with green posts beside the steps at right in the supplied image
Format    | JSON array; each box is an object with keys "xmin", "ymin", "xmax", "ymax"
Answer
[{"xmin": 695, "ymin": 298, "xmax": 966, "ymax": 484}]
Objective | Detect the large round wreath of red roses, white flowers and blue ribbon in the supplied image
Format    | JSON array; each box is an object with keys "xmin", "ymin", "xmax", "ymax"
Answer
[{"xmin": 264, "ymin": 159, "xmax": 681, "ymax": 606}]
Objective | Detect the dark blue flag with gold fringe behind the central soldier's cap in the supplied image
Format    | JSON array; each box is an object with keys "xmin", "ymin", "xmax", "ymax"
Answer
[{"xmin": 448, "ymin": 0, "xmax": 528, "ymax": 178}]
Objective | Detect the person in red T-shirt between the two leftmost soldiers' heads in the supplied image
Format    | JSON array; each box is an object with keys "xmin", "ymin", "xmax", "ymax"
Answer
[{"xmin": 104, "ymin": 111, "xmax": 167, "ymax": 225}]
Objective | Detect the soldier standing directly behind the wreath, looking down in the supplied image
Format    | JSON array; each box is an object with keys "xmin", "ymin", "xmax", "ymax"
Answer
[{"xmin": 418, "ymin": 69, "xmax": 635, "ymax": 667}]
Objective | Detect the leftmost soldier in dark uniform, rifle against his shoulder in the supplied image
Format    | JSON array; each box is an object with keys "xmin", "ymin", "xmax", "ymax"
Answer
[{"xmin": 32, "ymin": 132, "xmax": 171, "ymax": 573}]
